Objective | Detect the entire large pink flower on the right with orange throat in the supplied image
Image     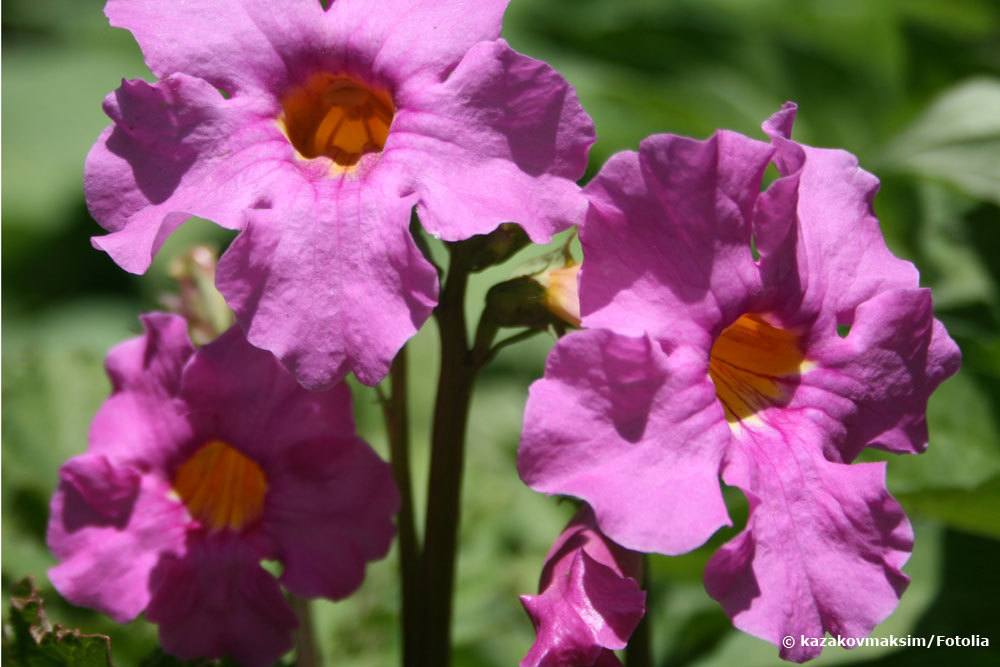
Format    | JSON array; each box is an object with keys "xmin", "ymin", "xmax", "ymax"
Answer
[{"xmin": 519, "ymin": 104, "xmax": 960, "ymax": 661}]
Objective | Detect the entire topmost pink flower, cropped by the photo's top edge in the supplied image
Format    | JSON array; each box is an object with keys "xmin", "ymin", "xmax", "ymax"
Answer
[{"xmin": 85, "ymin": 0, "xmax": 594, "ymax": 388}]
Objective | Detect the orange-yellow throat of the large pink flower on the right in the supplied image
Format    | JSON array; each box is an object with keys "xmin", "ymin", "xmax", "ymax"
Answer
[{"xmin": 708, "ymin": 314, "xmax": 807, "ymax": 424}]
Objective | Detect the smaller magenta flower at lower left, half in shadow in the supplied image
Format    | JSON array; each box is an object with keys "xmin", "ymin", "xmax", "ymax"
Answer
[{"xmin": 48, "ymin": 314, "xmax": 399, "ymax": 665}]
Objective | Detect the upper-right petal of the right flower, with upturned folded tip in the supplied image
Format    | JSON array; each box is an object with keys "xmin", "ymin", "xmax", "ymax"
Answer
[{"xmin": 754, "ymin": 103, "xmax": 918, "ymax": 324}]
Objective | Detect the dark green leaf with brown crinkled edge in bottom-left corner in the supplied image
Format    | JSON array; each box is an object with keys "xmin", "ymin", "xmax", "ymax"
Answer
[{"xmin": 3, "ymin": 577, "xmax": 111, "ymax": 667}]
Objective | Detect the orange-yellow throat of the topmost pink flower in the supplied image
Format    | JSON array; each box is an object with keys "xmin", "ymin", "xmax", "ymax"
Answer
[{"xmin": 278, "ymin": 72, "xmax": 396, "ymax": 172}]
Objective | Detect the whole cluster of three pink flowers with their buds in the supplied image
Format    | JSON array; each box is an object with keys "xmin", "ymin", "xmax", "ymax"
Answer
[{"xmin": 48, "ymin": 0, "xmax": 960, "ymax": 667}]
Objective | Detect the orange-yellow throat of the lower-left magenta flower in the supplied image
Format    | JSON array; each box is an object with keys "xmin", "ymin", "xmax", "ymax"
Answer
[{"xmin": 174, "ymin": 440, "xmax": 267, "ymax": 531}]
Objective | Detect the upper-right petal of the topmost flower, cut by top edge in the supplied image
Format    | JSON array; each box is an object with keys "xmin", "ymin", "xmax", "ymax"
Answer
[{"xmin": 329, "ymin": 0, "xmax": 509, "ymax": 85}]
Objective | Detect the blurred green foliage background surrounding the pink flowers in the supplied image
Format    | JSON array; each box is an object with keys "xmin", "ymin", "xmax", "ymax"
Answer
[{"xmin": 2, "ymin": 0, "xmax": 1000, "ymax": 667}]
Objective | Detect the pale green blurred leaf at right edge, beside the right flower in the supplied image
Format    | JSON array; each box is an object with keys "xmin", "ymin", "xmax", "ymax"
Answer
[{"xmin": 885, "ymin": 77, "xmax": 1000, "ymax": 203}]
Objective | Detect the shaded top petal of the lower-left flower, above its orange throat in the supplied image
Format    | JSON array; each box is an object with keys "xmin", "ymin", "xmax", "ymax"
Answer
[{"xmin": 181, "ymin": 326, "xmax": 354, "ymax": 468}]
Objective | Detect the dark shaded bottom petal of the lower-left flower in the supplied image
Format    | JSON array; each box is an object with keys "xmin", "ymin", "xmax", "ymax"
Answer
[{"xmin": 146, "ymin": 536, "xmax": 297, "ymax": 667}]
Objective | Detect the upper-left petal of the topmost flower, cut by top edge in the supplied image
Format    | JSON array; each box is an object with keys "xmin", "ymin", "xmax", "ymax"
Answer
[{"xmin": 104, "ymin": 0, "xmax": 326, "ymax": 93}]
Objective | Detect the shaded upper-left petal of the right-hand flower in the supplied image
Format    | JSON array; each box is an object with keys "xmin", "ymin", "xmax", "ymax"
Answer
[{"xmin": 580, "ymin": 131, "xmax": 772, "ymax": 350}]
